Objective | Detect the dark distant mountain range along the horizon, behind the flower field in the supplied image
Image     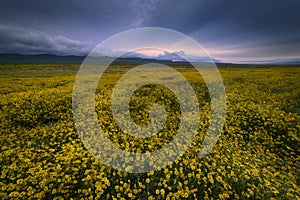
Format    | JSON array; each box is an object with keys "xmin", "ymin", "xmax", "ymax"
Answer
[{"xmin": 0, "ymin": 53, "xmax": 300, "ymax": 65}]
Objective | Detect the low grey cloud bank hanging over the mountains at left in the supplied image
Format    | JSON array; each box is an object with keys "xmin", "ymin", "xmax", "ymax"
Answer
[{"xmin": 0, "ymin": 26, "xmax": 92, "ymax": 55}]
